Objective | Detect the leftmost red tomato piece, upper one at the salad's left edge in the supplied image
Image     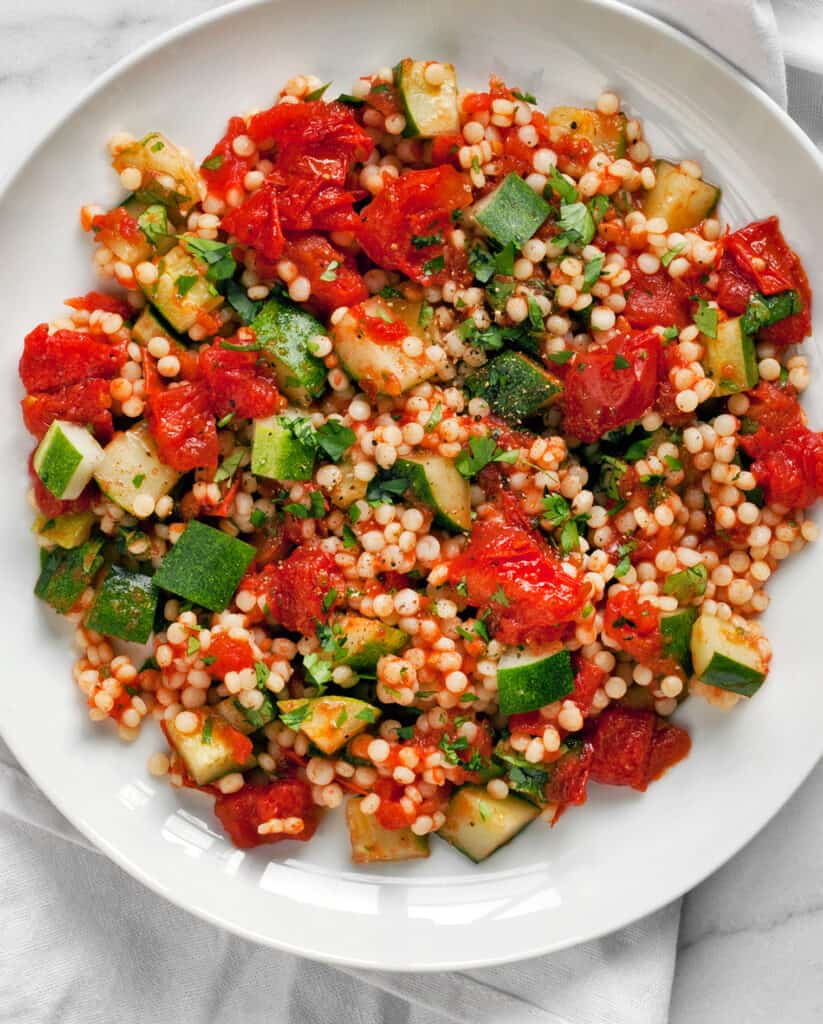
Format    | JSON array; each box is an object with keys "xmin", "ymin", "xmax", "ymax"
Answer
[{"xmin": 19, "ymin": 324, "xmax": 126, "ymax": 391}]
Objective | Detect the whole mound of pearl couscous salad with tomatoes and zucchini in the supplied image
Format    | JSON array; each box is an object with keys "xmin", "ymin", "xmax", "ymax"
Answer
[{"xmin": 19, "ymin": 64, "xmax": 823, "ymax": 863}]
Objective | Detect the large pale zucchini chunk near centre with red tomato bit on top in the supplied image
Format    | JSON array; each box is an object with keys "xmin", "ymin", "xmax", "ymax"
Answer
[{"xmin": 332, "ymin": 296, "xmax": 435, "ymax": 395}]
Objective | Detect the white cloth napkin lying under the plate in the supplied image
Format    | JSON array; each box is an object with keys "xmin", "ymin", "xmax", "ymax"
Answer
[{"xmin": 0, "ymin": 0, "xmax": 823, "ymax": 1024}]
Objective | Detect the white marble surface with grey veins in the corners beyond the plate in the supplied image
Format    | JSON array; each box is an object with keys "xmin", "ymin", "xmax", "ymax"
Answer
[{"xmin": 0, "ymin": 0, "xmax": 823, "ymax": 1024}]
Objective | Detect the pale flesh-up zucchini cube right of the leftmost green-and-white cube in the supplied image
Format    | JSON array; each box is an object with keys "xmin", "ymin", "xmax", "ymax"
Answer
[{"xmin": 94, "ymin": 423, "xmax": 180, "ymax": 515}]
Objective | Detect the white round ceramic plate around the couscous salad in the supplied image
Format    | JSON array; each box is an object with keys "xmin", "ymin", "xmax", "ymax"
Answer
[{"xmin": 0, "ymin": 0, "xmax": 823, "ymax": 970}]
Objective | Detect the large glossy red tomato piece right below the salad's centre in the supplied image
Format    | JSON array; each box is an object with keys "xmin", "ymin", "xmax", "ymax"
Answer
[{"xmin": 449, "ymin": 518, "xmax": 587, "ymax": 644}]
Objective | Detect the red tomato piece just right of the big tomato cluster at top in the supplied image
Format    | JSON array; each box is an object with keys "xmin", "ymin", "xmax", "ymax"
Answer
[{"xmin": 359, "ymin": 164, "xmax": 472, "ymax": 285}]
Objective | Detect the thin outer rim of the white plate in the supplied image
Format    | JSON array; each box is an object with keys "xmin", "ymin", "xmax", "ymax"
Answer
[{"xmin": 0, "ymin": 0, "xmax": 823, "ymax": 974}]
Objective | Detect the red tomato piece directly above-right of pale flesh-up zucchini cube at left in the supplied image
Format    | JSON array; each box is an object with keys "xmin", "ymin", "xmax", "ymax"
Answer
[{"xmin": 147, "ymin": 381, "xmax": 219, "ymax": 473}]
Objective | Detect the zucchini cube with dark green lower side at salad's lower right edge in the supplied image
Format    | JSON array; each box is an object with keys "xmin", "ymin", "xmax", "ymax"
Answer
[{"xmin": 691, "ymin": 611, "xmax": 768, "ymax": 697}]
